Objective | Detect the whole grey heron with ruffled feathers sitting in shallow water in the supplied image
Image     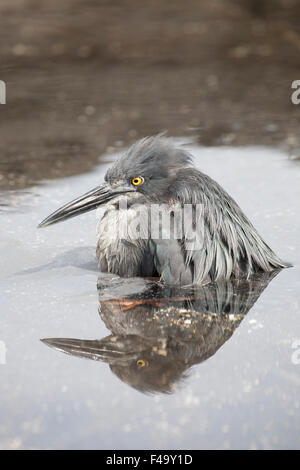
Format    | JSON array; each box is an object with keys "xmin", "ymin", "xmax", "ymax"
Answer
[{"xmin": 38, "ymin": 134, "xmax": 290, "ymax": 286}]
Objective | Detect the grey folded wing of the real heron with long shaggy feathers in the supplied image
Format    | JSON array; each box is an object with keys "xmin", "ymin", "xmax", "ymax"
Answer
[{"xmin": 151, "ymin": 168, "xmax": 286, "ymax": 284}]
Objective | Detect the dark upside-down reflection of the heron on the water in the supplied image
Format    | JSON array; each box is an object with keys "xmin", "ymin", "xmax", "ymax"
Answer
[{"xmin": 43, "ymin": 271, "xmax": 277, "ymax": 393}]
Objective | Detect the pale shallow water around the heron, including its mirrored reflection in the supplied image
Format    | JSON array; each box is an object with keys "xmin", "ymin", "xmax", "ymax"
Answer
[{"xmin": 0, "ymin": 144, "xmax": 300, "ymax": 449}]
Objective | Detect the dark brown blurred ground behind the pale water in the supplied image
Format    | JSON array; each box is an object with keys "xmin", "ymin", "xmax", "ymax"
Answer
[{"xmin": 0, "ymin": 0, "xmax": 300, "ymax": 189}]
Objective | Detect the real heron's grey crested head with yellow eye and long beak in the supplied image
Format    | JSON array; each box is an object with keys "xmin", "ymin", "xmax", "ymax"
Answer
[{"xmin": 39, "ymin": 135, "xmax": 191, "ymax": 227}]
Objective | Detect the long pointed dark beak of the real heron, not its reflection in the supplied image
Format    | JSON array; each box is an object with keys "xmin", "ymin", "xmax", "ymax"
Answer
[{"xmin": 38, "ymin": 183, "xmax": 134, "ymax": 228}]
